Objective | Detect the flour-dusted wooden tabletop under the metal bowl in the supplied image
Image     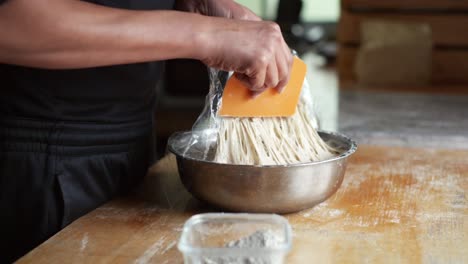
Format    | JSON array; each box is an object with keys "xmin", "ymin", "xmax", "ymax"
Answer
[{"xmin": 19, "ymin": 145, "xmax": 468, "ymax": 264}]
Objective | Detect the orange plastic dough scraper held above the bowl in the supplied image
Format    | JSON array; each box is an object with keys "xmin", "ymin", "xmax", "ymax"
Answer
[{"xmin": 219, "ymin": 57, "xmax": 307, "ymax": 117}]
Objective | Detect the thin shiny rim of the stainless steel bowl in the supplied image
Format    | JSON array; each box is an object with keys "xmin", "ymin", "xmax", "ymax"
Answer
[{"xmin": 168, "ymin": 130, "xmax": 357, "ymax": 168}]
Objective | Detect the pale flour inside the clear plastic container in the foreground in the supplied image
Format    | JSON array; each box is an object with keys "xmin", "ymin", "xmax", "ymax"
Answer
[{"xmin": 201, "ymin": 230, "xmax": 283, "ymax": 264}]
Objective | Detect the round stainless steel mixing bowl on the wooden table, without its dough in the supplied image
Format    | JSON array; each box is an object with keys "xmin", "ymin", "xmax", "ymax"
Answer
[{"xmin": 168, "ymin": 131, "xmax": 357, "ymax": 213}]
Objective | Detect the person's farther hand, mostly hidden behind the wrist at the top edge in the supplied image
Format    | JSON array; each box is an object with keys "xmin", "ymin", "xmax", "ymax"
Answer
[{"xmin": 176, "ymin": 0, "xmax": 261, "ymax": 21}]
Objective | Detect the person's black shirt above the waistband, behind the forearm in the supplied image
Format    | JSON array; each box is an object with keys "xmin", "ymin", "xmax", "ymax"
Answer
[{"xmin": 0, "ymin": 0, "xmax": 174, "ymax": 122}]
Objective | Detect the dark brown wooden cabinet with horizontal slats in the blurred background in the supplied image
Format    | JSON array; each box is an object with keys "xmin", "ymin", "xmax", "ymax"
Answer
[{"xmin": 338, "ymin": 0, "xmax": 468, "ymax": 84}]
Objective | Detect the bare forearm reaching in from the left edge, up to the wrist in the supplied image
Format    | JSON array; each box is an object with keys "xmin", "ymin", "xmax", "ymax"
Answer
[{"xmin": 0, "ymin": 0, "xmax": 212, "ymax": 69}]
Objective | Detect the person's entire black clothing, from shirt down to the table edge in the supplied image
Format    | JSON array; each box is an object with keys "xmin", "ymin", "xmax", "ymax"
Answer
[{"xmin": 0, "ymin": 0, "xmax": 174, "ymax": 263}]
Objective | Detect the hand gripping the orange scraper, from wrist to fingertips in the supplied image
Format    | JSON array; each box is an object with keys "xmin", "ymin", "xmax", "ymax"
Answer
[{"xmin": 200, "ymin": 19, "xmax": 293, "ymax": 95}]
